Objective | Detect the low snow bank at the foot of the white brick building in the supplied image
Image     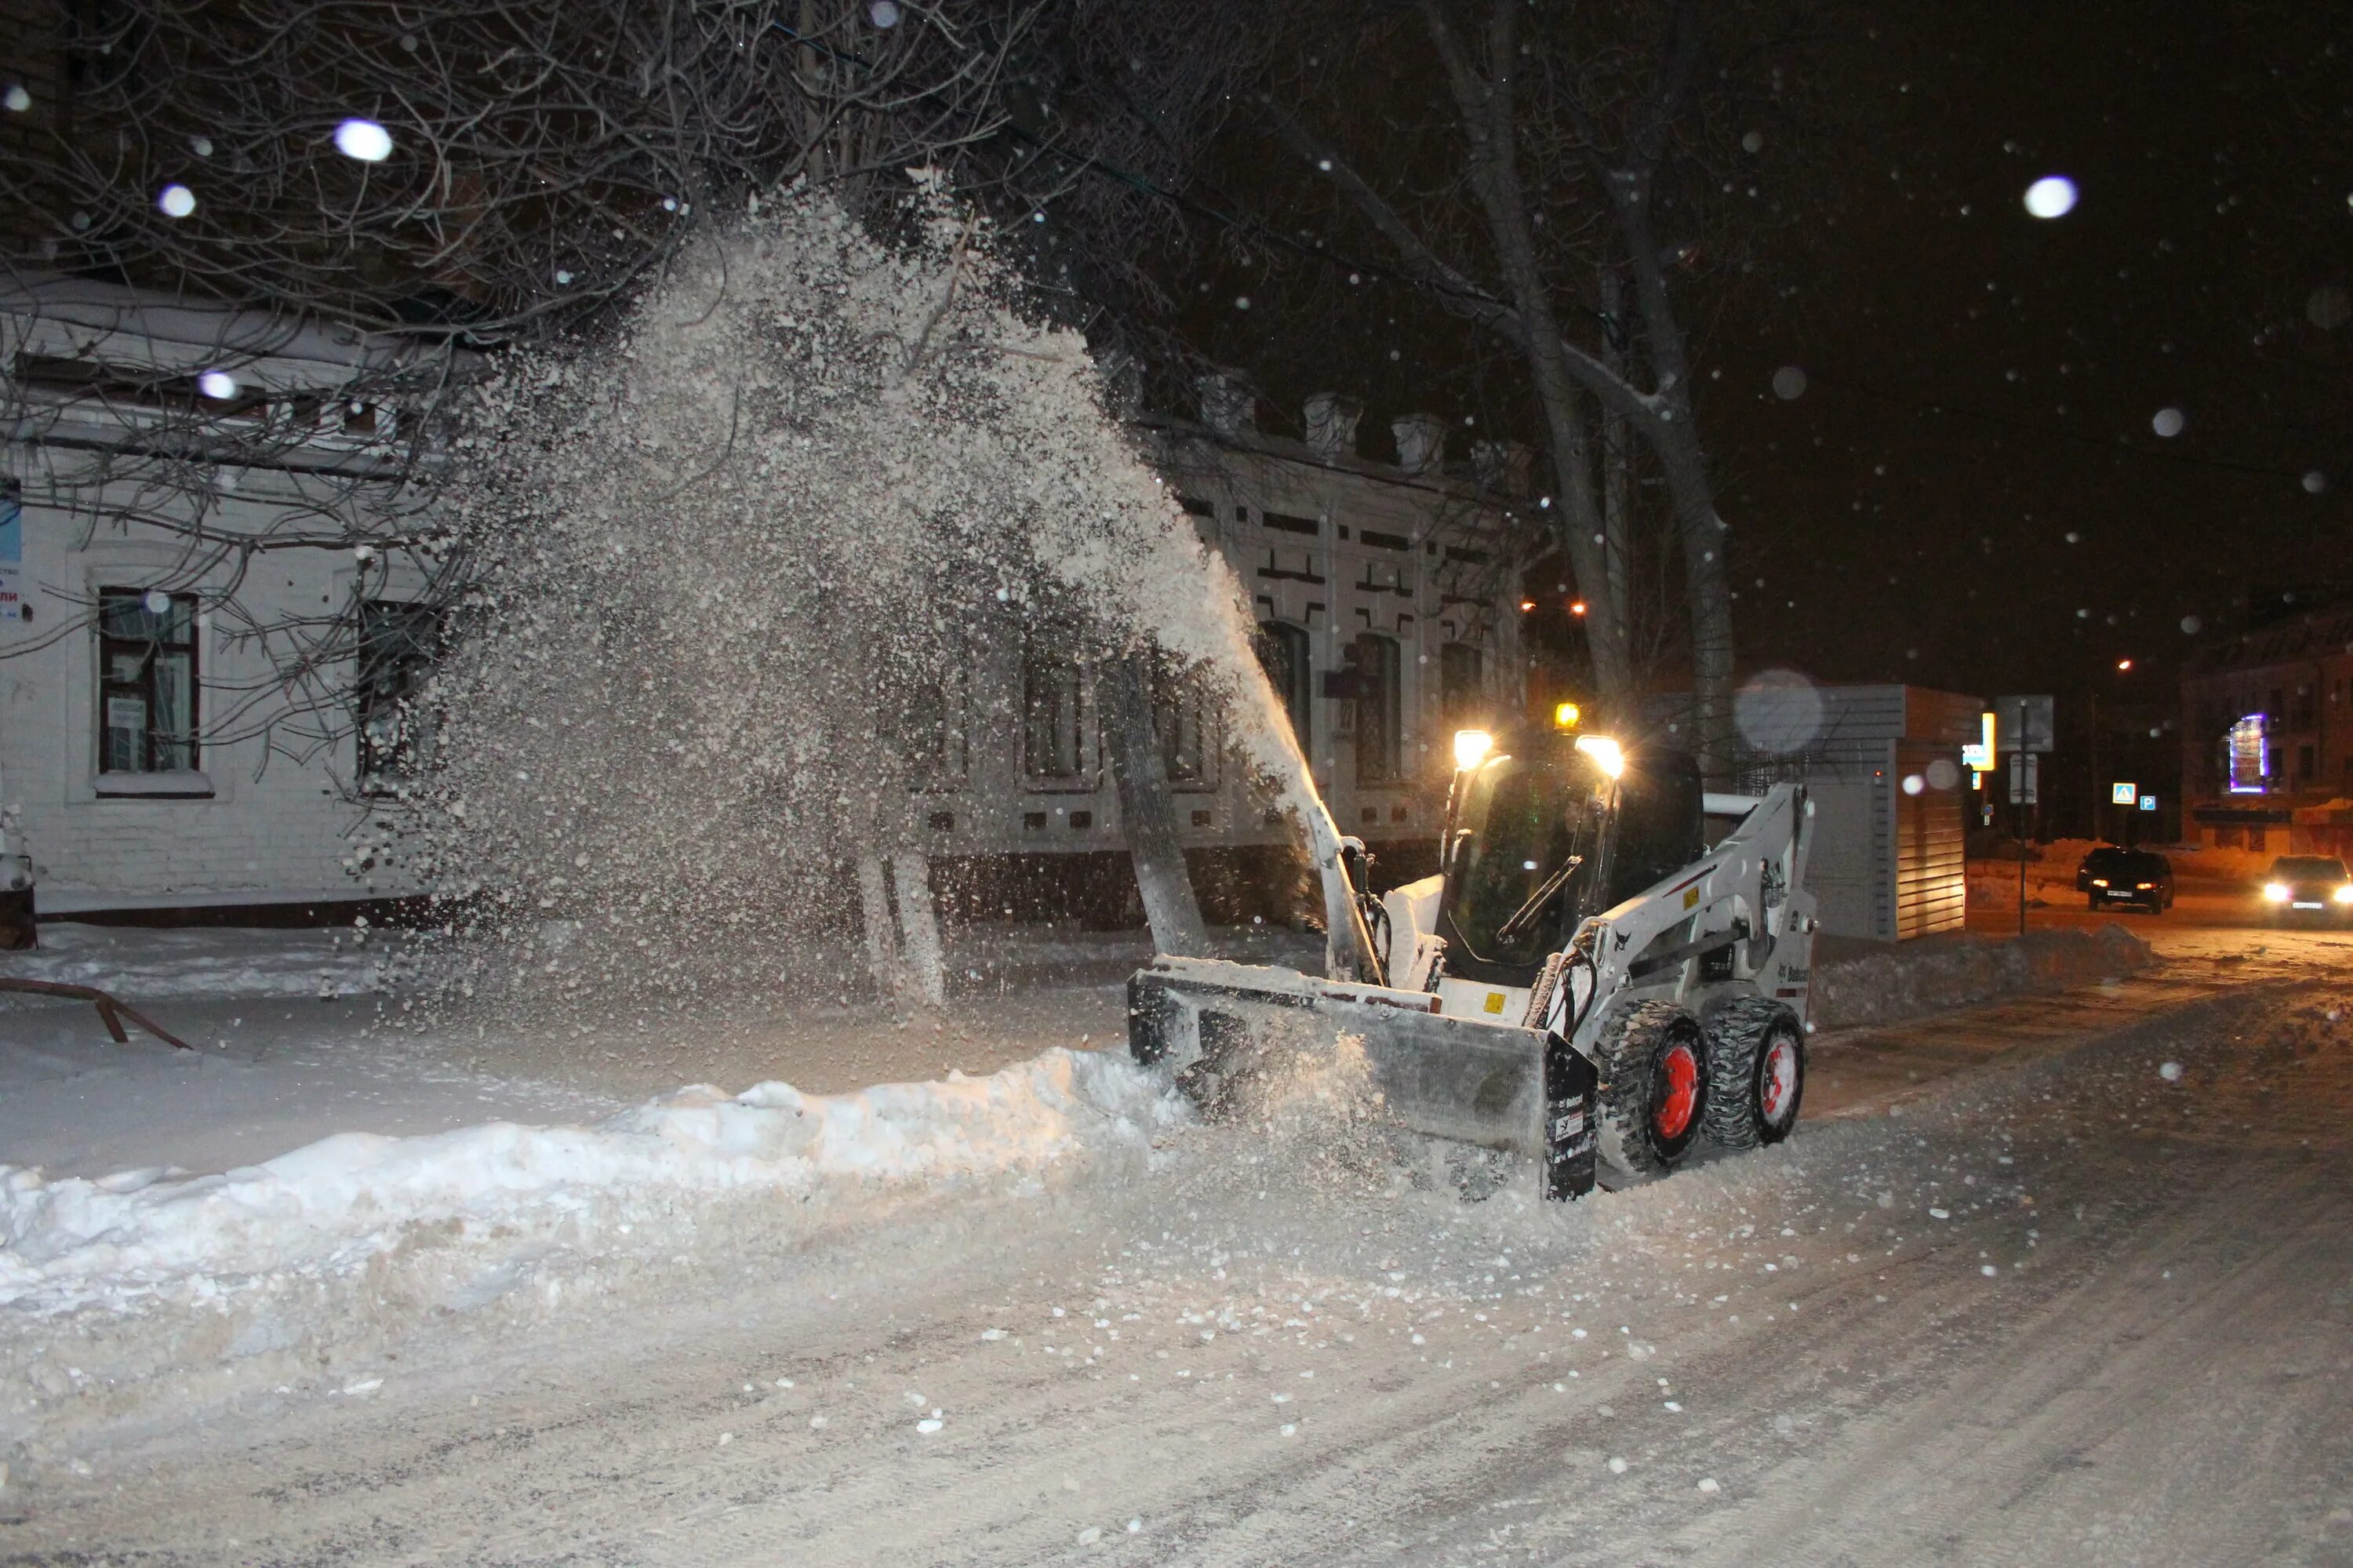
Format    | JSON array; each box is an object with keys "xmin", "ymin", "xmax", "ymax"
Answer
[{"xmin": 0, "ymin": 923, "xmax": 412, "ymax": 1006}]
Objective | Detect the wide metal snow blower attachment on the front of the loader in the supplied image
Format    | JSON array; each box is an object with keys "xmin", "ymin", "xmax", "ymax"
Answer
[{"xmin": 1127, "ymin": 956, "xmax": 1595, "ymax": 1199}]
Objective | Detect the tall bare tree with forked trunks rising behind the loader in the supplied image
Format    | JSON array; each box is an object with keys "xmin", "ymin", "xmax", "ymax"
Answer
[{"xmin": 1261, "ymin": 0, "xmax": 1817, "ymax": 769}]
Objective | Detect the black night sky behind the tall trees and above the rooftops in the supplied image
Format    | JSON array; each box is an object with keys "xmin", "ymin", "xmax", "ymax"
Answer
[{"xmin": 1153, "ymin": 0, "xmax": 2353, "ymax": 701}]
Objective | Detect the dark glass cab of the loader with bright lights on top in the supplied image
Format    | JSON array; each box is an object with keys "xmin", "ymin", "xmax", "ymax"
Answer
[{"xmin": 1438, "ymin": 729, "xmax": 1706, "ymax": 987}]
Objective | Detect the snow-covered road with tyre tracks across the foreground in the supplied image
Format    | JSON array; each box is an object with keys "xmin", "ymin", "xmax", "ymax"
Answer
[{"xmin": 0, "ymin": 947, "xmax": 2353, "ymax": 1568}]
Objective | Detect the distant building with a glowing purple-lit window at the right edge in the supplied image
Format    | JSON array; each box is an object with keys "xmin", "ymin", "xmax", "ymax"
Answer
[{"xmin": 2181, "ymin": 600, "xmax": 2353, "ymax": 855}]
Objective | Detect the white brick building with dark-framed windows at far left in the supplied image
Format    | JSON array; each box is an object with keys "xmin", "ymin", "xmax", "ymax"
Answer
[{"xmin": 0, "ymin": 280, "xmax": 442, "ymax": 914}]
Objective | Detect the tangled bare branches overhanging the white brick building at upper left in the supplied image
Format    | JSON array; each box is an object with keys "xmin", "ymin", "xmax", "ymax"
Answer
[{"xmin": 0, "ymin": 0, "xmax": 1040, "ymax": 777}]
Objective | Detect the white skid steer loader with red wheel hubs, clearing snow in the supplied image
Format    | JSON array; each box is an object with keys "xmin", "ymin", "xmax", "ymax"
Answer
[{"xmin": 1127, "ymin": 704, "xmax": 1817, "ymax": 1199}]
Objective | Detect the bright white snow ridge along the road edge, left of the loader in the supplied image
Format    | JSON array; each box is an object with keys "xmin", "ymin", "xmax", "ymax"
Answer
[{"xmin": 0, "ymin": 1050, "xmax": 1181, "ymax": 1314}]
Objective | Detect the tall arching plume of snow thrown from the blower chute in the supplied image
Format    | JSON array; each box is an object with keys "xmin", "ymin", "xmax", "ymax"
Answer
[{"xmin": 398, "ymin": 193, "xmax": 1301, "ymax": 999}]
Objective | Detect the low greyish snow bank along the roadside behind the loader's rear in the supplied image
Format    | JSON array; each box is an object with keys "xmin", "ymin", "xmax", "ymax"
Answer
[{"xmin": 1814, "ymin": 926, "xmax": 2155, "ymax": 1029}]
